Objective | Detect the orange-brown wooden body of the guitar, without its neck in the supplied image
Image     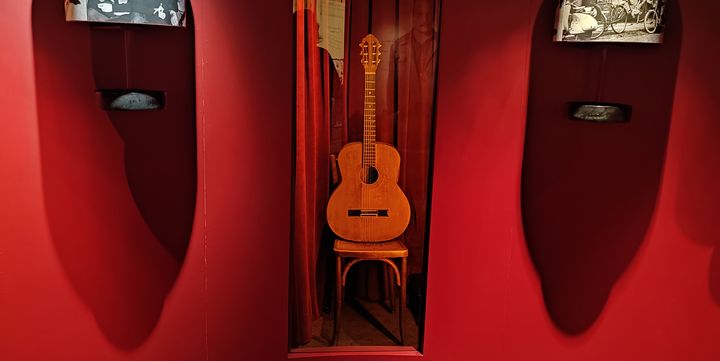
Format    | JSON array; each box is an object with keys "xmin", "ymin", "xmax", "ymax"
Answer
[{"xmin": 327, "ymin": 142, "xmax": 410, "ymax": 242}]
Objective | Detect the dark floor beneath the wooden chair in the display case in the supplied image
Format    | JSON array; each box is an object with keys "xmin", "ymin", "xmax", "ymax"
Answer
[{"xmin": 300, "ymin": 300, "xmax": 418, "ymax": 349}]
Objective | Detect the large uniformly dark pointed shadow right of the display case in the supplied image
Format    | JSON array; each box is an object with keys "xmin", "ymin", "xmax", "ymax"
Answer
[{"xmin": 522, "ymin": 0, "xmax": 682, "ymax": 335}]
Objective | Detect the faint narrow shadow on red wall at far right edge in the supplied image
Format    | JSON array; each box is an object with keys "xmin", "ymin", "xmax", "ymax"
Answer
[{"xmin": 675, "ymin": 36, "xmax": 720, "ymax": 305}]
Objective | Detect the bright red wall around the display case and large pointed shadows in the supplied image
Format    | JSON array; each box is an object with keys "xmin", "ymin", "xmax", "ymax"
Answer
[{"xmin": 0, "ymin": 0, "xmax": 720, "ymax": 361}]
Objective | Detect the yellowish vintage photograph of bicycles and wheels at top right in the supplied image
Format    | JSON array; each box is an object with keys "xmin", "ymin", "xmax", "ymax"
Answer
[{"xmin": 554, "ymin": 0, "xmax": 666, "ymax": 44}]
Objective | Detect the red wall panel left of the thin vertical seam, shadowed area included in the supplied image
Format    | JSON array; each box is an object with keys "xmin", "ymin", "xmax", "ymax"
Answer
[{"xmin": 0, "ymin": 0, "xmax": 204, "ymax": 360}]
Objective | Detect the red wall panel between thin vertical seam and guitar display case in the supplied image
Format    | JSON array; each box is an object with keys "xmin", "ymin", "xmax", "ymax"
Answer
[{"xmin": 196, "ymin": 1, "xmax": 293, "ymax": 360}]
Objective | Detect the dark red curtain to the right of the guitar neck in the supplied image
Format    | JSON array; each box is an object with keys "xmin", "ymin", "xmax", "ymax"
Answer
[{"xmin": 388, "ymin": 0, "xmax": 438, "ymax": 273}]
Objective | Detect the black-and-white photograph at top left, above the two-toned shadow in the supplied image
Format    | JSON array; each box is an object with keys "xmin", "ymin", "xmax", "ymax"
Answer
[{"xmin": 65, "ymin": 0, "xmax": 186, "ymax": 27}]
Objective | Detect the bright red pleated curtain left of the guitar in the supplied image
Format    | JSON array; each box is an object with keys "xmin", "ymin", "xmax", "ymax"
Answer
[{"xmin": 291, "ymin": 0, "xmax": 330, "ymax": 346}]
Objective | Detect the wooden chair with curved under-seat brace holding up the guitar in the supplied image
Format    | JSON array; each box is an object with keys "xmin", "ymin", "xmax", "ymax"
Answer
[{"xmin": 330, "ymin": 155, "xmax": 408, "ymax": 346}]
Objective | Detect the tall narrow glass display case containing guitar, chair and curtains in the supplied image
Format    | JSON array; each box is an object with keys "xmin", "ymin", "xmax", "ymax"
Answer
[{"xmin": 290, "ymin": 0, "xmax": 440, "ymax": 351}]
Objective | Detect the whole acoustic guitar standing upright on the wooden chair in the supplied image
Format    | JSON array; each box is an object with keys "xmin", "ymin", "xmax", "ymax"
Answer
[{"xmin": 327, "ymin": 34, "xmax": 410, "ymax": 242}]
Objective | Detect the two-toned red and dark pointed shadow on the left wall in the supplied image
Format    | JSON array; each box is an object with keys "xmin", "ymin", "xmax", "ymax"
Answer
[{"xmin": 32, "ymin": 0, "xmax": 197, "ymax": 350}]
